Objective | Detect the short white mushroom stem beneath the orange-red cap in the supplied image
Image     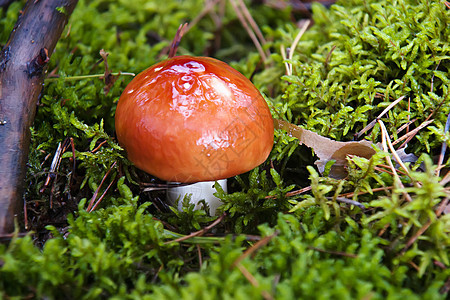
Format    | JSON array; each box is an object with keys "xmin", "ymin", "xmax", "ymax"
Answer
[{"xmin": 167, "ymin": 179, "xmax": 227, "ymax": 216}]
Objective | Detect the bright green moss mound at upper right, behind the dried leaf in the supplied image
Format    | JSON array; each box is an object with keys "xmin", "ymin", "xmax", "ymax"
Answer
[{"xmin": 277, "ymin": 1, "xmax": 450, "ymax": 148}]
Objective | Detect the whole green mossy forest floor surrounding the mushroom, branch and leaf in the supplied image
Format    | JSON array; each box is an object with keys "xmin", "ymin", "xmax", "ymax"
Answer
[{"xmin": 0, "ymin": 0, "xmax": 450, "ymax": 299}]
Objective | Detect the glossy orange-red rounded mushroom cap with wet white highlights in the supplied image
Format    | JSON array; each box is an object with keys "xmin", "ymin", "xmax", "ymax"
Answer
[{"xmin": 115, "ymin": 56, "xmax": 274, "ymax": 182}]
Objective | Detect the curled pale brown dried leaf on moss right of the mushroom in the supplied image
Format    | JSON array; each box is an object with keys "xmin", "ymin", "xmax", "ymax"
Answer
[{"xmin": 274, "ymin": 119, "xmax": 375, "ymax": 179}]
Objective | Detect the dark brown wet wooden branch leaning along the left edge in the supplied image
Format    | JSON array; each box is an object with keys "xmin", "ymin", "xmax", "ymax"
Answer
[{"xmin": 0, "ymin": 0, "xmax": 78, "ymax": 235}]
